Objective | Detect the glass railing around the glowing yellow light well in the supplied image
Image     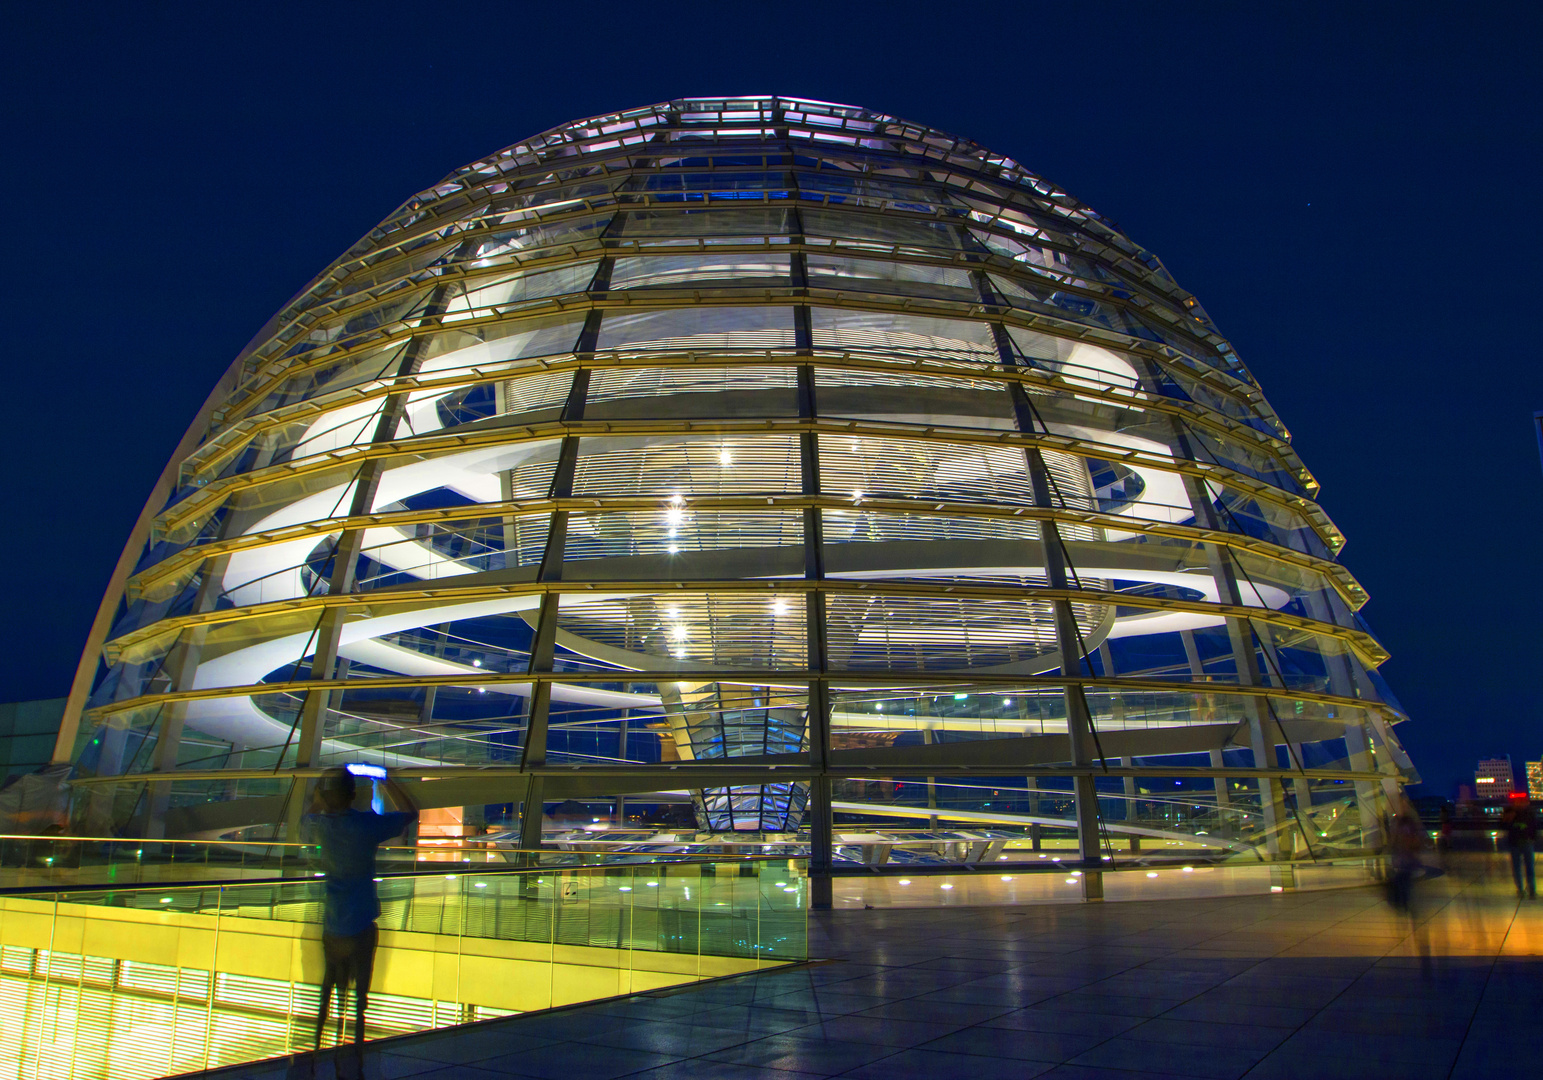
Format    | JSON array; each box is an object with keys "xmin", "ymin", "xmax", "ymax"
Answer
[{"xmin": 0, "ymin": 858, "xmax": 809, "ymax": 1080}]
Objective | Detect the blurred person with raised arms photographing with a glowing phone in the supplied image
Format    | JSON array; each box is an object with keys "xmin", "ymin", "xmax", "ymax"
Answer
[{"xmin": 302, "ymin": 768, "xmax": 418, "ymax": 1073}]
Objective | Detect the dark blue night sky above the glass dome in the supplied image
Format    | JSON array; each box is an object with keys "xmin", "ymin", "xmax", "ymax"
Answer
[{"xmin": 0, "ymin": 3, "xmax": 1543, "ymax": 791}]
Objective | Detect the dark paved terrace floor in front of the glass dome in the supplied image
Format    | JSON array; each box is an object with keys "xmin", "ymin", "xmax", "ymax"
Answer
[{"xmin": 207, "ymin": 878, "xmax": 1543, "ymax": 1080}]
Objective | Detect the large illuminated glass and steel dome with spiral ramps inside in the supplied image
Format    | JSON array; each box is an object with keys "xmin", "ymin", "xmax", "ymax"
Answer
[{"xmin": 56, "ymin": 97, "xmax": 1410, "ymax": 901}]
